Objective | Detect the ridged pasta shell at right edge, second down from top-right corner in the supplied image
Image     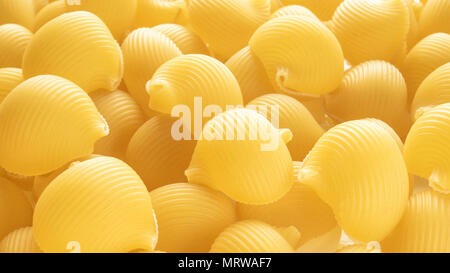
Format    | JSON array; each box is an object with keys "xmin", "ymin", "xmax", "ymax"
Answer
[{"xmin": 401, "ymin": 33, "xmax": 450, "ymax": 102}]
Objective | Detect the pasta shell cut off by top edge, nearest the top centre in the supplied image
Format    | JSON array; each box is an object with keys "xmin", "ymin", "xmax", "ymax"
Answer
[{"xmin": 187, "ymin": 0, "xmax": 270, "ymax": 61}]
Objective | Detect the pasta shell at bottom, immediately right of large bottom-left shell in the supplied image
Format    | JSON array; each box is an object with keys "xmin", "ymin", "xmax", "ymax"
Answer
[{"xmin": 150, "ymin": 183, "xmax": 236, "ymax": 253}]
